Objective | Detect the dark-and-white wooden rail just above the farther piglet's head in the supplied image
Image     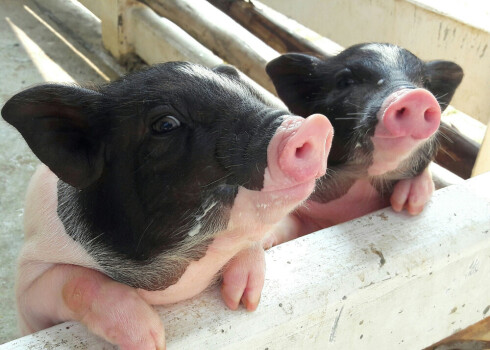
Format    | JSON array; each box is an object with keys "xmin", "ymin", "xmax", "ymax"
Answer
[{"xmin": 208, "ymin": 0, "xmax": 342, "ymax": 57}]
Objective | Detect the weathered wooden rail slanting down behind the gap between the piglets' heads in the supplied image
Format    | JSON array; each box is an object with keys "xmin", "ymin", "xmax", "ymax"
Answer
[{"xmin": 141, "ymin": 0, "xmax": 279, "ymax": 91}]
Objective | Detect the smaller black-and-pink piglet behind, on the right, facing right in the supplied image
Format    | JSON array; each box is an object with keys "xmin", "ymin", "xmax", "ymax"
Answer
[{"xmin": 267, "ymin": 43, "xmax": 463, "ymax": 233}]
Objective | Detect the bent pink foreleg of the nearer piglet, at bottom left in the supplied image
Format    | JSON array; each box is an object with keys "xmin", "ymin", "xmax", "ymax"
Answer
[{"xmin": 21, "ymin": 265, "xmax": 165, "ymax": 350}]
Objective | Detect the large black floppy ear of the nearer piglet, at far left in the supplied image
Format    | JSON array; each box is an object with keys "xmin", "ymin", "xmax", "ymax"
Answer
[{"xmin": 2, "ymin": 84, "xmax": 104, "ymax": 189}]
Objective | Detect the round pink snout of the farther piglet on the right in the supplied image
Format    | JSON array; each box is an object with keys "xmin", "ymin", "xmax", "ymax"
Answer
[{"xmin": 375, "ymin": 89, "xmax": 441, "ymax": 139}]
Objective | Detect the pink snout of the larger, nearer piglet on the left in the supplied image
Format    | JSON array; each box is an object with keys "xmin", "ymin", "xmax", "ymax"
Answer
[{"xmin": 278, "ymin": 114, "xmax": 333, "ymax": 183}]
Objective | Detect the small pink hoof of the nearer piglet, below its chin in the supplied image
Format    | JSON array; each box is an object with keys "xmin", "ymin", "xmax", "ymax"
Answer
[{"xmin": 221, "ymin": 244, "xmax": 265, "ymax": 311}]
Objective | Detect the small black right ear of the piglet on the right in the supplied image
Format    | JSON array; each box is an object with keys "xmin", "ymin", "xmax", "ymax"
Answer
[{"xmin": 425, "ymin": 60, "xmax": 464, "ymax": 110}]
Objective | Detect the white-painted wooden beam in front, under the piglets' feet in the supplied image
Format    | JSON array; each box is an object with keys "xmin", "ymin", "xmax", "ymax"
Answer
[{"xmin": 0, "ymin": 174, "xmax": 490, "ymax": 350}]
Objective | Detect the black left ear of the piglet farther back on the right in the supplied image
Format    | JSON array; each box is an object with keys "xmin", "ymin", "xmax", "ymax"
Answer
[{"xmin": 265, "ymin": 53, "xmax": 323, "ymax": 116}]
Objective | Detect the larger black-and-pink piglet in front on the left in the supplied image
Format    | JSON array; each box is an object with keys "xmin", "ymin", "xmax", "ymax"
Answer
[{"xmin": 2, "ymin": 62, "xmax": 332, "ymax": 349}]
